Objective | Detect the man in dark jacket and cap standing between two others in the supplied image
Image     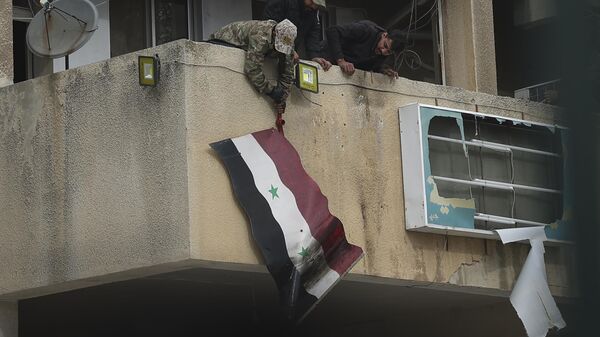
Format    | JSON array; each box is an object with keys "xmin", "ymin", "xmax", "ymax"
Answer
[{"xmin": 263, "ymin": 0, "xmax": 331, "ymax": 70}]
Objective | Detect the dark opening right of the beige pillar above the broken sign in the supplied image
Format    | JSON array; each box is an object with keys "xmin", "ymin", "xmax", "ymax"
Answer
[{"xmin": 493, "ymin": 0, "xmax": 561, "ymax": 104}]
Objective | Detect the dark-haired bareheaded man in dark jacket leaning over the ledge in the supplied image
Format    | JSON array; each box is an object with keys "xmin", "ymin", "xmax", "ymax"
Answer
[{"xmin": 322, "ymin": 20, "xmax": 402, "ymax": 77}]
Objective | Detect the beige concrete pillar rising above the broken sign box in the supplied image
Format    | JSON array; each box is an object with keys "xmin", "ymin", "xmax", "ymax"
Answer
[{"xmin": 441, "ymin": 0, "xmax": 498, "ymax": 94}]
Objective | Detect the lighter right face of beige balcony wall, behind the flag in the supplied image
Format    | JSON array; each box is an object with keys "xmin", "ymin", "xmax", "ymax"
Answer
[{"xmin": 182, "ymin": 44, "xmax": 571, "ymax": 294}]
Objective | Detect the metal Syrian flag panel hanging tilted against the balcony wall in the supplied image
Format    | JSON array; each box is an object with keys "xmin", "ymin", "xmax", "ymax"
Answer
[{"xmin": 210, "ymin": 129, "xmax": 363, "ymax": 322}]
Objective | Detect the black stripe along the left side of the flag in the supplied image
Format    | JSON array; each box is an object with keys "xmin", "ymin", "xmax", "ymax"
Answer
[{"xmin": 210, "ymin": 139, "xmax": 317, "ymax": 320}]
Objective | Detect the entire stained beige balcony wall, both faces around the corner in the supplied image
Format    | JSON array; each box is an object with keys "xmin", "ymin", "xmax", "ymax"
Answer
[{"xmin": 0, "ymin": 41, "xmax": 573, "ymax": 298}]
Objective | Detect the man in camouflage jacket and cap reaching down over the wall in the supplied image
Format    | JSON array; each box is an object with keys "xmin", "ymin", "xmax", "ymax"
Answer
[{"xmin": 210, "ymin": 20, "xmax": 297, "ymax": 106}]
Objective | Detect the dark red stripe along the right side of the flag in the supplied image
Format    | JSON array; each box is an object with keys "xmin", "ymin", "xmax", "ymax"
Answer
[{"xmin": 252, "ymin": 129, "xmax": 362, "ymax": 275}]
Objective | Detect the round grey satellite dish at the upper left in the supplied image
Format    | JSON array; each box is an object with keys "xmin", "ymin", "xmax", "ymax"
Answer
[{"xmin": 27, "ymin": 0, "xmax": 98, "ymax": 58}]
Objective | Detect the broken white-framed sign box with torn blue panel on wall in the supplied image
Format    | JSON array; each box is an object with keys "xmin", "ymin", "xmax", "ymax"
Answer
[{"xmin": 400, "ymin": 104, "xmax": 571, "ymax": 242}]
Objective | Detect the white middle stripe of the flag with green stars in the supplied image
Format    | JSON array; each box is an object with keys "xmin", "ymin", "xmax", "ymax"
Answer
[{"xmin": 231, "ymin": 134, "xmax": 340, "ymax": 298}]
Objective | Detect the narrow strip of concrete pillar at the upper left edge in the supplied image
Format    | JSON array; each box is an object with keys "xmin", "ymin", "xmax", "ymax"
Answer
[{"xmin": 0, "ymin": 0, "xmax": 13, "ymax": 87}]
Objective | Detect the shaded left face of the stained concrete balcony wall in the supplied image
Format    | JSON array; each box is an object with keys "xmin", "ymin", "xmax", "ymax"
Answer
[{"xmin": 0, "ymin": 44, "xmax": 189, "ymax": 296}]
